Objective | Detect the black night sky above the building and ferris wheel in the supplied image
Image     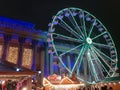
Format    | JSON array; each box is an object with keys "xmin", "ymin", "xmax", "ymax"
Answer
[{"xmin": 0, "ymin": 0, "xmax": 120, "ymax": 60}]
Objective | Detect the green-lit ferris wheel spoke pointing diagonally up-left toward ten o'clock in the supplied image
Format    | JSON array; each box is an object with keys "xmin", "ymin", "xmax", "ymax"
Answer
[{"xmin": 59, "ymin": 20, "xmax": 81, "ymax": 39}]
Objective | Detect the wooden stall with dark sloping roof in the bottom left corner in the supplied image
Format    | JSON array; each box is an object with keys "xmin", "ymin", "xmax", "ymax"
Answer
[{"xmin": 0, "ymin": 62, "xmax": 35, "ymax": 90}]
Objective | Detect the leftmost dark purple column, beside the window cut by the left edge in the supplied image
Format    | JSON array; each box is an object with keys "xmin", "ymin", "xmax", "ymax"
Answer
[{"xmin": 2, "ymin": 35, "xmax": 11, "ymax": 61}]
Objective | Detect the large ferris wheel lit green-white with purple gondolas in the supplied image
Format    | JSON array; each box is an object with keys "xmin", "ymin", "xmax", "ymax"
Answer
[{"xmin": 48, "ymin": 8, "xmax": 118, "ymax": 83}]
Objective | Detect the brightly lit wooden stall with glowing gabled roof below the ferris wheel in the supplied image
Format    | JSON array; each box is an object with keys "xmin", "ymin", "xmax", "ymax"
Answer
[{"xmin": 43, "ymin": 74, "xmax": 85, "ymax": 90}]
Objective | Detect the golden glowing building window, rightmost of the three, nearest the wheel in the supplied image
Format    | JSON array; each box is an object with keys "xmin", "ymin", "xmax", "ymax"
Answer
[{"xmin": 22, "ymin": 48, "xmax": 33, "ymax": 69}]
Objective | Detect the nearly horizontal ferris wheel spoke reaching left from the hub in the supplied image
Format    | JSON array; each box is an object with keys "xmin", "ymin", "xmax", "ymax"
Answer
[{"xmin": 52, "ymin": 33, "xmax": 82, "ymax": 43}]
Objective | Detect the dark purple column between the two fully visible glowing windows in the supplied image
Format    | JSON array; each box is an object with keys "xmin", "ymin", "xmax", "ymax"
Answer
[{"xmin": 18, "ymin": 38, "xmax": 25, "ymax": 66}]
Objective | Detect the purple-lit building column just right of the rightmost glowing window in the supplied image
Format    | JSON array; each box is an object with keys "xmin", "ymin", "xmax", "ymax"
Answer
[{"xmin": 32, "ymin": 40, "xmax": 38, "ymax": 71}]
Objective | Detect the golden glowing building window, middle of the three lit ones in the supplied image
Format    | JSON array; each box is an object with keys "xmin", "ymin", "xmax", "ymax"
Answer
[{"xmin": 7, "ymin": 46, "xmax": 18, "ymax": 64}]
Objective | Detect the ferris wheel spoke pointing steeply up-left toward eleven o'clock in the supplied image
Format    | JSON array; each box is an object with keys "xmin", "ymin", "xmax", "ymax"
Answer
[{"xmin": 69, "ymin": 10, "xmax": 84, "ymax": 39}]
